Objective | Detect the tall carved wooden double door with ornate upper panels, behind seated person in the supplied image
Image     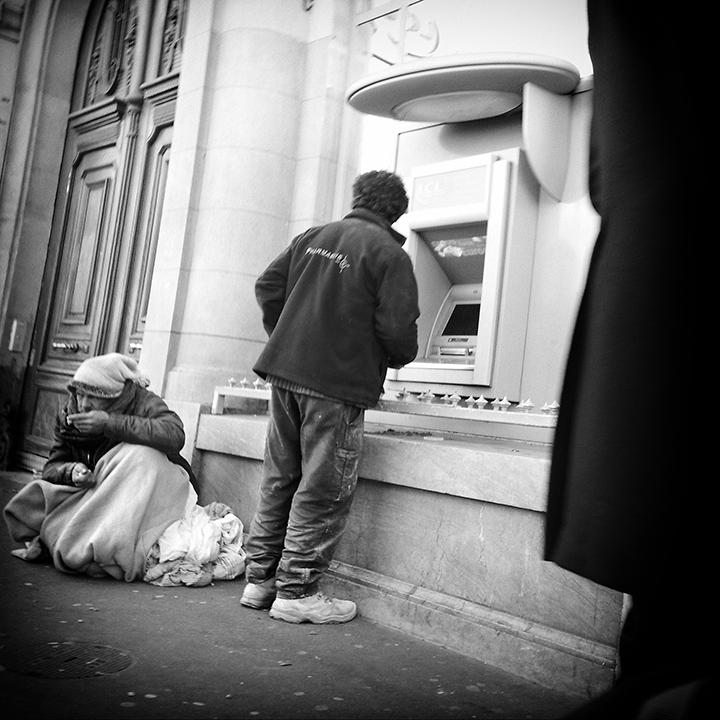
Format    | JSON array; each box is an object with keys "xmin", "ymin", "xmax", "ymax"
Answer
[{"xmin": 20, "ymin": 0, "xmax": 184, "ymax": 467}]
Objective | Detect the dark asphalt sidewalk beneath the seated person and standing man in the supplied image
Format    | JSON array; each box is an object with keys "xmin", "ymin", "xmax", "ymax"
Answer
[{"xmin": 0, "ymin": 472, "xmax": 583, "ymax": 720}]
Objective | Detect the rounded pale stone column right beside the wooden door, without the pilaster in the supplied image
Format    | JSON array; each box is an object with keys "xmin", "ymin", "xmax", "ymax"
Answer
[{"xmin": 141, "ymin": 0, "xmax": 308, "ymax": 403}]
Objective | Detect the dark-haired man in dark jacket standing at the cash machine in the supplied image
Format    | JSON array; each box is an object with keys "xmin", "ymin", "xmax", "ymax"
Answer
[{"xmin": 240, "ymin": 171, "xmax": 420, "ymax": 624}]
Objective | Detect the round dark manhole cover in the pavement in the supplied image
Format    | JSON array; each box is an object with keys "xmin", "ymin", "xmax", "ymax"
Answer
[{"xmin": 2, "ymin": 642, "xmax": 133, "ymax": 678}]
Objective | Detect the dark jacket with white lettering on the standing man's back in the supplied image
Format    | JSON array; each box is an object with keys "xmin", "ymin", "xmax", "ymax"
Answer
[{"xmin": 254, "ymin": 208, "xmax": 420, "ymax": 408}]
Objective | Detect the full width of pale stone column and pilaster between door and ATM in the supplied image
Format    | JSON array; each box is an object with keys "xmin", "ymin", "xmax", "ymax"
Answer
[{"xmin": 141, "ymin": 0, "xmax": 366, "ymax": 404}]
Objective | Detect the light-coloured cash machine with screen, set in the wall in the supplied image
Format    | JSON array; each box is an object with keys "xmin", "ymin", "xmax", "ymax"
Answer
[{"xmin": 385, "ymin": 148, "xmax": 539, "ymax": 401}]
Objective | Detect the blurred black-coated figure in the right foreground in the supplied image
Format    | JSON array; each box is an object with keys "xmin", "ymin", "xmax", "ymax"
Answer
[{"xmin": 545, "ymin": 0, "xmax": 717, "ymax": 718}]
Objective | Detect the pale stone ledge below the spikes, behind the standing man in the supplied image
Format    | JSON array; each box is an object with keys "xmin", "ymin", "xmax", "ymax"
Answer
[{"xmin": 196, "ymin": 414, "xmax": 550, "ymax": 512}]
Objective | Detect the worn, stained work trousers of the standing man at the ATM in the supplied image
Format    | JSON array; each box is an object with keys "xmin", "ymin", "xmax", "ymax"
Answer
[{"xmin": 245, "ymin": 386, "xmax": 365, "ymax": 599}]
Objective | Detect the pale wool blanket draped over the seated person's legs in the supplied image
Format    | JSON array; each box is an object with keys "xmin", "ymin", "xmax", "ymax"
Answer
[{"xmin": 3, "ymin": 443, "xmax": 197, "ymax": 582}]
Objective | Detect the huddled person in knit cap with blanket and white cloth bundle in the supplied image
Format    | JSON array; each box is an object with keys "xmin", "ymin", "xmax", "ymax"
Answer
[{"xmin": 3, "ymin": 353, "xmax": 244, "ymax": 585}]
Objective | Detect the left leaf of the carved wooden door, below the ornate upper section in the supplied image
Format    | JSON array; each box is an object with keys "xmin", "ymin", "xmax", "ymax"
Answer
[{"xmin": 23, "ymin": 110, "xmax": 120, "ymax": 456}]
